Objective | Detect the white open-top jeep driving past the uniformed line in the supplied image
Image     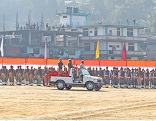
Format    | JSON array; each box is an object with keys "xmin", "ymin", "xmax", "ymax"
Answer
[{"xmin": 49, "ymin": 68, "xmax": 103, "ymax": 91}]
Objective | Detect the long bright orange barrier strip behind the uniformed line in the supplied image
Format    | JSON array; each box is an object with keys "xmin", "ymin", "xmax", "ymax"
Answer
[{"xmin": 0, "ymin": 58, "xmax": 156, "ymax": 67}]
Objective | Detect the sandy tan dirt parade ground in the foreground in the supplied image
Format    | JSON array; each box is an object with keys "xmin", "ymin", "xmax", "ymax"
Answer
[{"xmin": 0, "ymin": 86, "xmax": 156, "ymax": 120}]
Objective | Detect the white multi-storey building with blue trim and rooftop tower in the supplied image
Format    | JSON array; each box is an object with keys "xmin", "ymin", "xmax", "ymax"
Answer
[{"xmin": 57, "ymin": 7, "xmax": 147, "ymax": 60}]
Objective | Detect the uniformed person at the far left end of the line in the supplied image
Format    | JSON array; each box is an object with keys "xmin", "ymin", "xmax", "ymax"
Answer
[{"xmin": 1, "ymin": 66, "xmax": 8, "ymax": 86}]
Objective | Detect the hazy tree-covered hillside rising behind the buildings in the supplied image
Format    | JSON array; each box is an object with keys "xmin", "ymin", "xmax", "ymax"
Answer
[{"xmin": 0, "ymin": 0, "xmax": 156, "ymax": 30}]
